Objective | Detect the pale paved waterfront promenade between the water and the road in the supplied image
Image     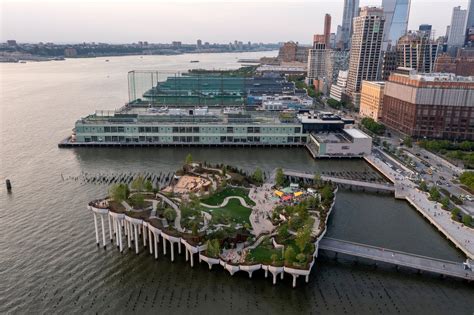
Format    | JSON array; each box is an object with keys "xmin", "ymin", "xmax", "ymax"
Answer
[{"xmin": 365, "ymin": 155, "xmax": 474, "ymax": 259}]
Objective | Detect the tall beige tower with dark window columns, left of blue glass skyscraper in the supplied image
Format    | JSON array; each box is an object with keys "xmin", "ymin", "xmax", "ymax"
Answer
[{"xmin": 347, "ymin": 7, "xmax": 385, "ymax": 106}]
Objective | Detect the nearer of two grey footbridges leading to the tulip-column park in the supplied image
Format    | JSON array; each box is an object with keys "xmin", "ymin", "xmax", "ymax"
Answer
[{"xmin": 319, "ymin": 237, "xmax": 474, "ymax": 281}]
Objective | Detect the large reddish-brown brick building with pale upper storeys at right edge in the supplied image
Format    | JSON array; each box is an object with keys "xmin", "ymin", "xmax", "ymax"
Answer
[{"xmin": 382, "ymin": 69, "xmax": 474, "ymax": 140}]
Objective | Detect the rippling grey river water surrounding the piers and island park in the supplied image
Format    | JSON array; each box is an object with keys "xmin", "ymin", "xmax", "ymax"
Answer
[{"xmin": 0, "ymin": 52, "xmax": 474, "ymax": 314}]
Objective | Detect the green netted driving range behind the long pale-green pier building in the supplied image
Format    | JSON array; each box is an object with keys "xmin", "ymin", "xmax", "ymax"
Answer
[{"xmin": 128, "ymin": 71, "xmax": 295, "ymax": 106}]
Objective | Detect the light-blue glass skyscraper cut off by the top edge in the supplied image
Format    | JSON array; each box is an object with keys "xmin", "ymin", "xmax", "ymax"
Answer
[{"xmin": 382, "ymin": 0, "xmax": 411, "ymax": 49}]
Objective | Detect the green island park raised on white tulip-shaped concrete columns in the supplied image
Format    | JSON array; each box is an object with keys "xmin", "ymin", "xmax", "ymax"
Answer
[{"xmin": 88, "ymin": 156, "xmax": 337, "ymax": 287}]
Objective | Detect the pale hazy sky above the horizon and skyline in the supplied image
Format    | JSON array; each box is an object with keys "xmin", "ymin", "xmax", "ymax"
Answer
[{"xmin": 0, "ymin": 0, "xmax": 468, "ymax": 44}]
